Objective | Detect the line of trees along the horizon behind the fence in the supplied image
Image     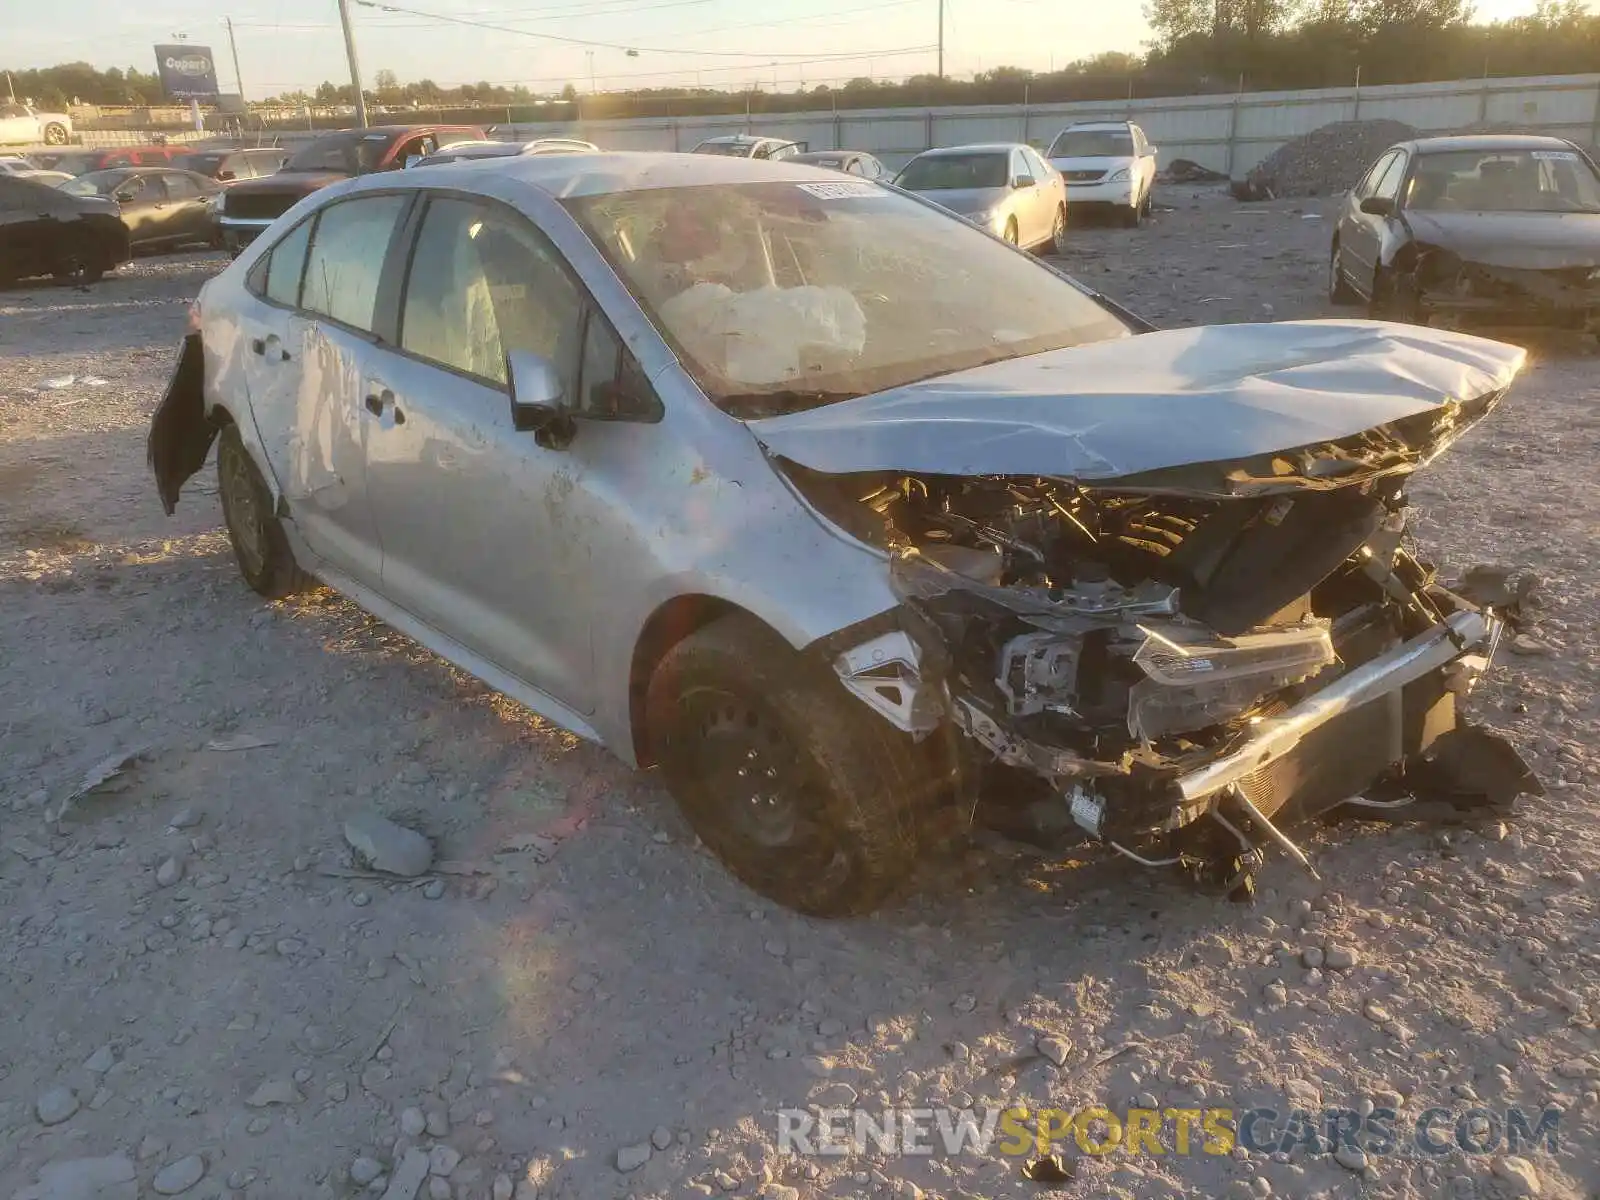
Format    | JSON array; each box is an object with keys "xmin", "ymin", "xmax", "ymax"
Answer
[{"xmin": 11, "ymin": 0, "xmax": 1600, "ymax": 120}]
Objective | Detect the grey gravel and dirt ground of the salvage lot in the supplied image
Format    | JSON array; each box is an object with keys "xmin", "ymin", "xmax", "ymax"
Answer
[{"xmin": 0, "ymin": 189, "xmax": 1600, "ymax": 1200}]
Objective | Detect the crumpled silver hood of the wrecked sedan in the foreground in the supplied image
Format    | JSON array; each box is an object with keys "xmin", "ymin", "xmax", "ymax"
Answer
[{"xmin": 749, "ymin": 320, "xmax": 1526, "ymax": 482}]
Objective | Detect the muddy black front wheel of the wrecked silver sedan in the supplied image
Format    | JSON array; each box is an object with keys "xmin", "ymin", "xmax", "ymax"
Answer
[{"xmin": 646, "ymin": 613, "xmax": 950, "ymax": 917}]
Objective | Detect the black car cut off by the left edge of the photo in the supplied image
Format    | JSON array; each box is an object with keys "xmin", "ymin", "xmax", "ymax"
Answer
[{"xmin": 0, "ymin": 174, "xmax": 131, "ymax": 283}]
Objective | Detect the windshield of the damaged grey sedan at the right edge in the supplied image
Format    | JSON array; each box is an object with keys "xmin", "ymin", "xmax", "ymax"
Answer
[{"xmin": 1405, "ymin": 150, "xmax": 1600, "ymax": 213}]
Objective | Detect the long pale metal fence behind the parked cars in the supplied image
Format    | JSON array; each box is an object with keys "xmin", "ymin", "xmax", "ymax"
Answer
[{"xmin": 83, "ymin": 74, "xmax": 1600, "ymax": 179}]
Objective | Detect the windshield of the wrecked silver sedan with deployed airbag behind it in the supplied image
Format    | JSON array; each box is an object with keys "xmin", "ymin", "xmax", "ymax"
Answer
[{"xmin": 563, "ymin": 179, "xmax": 1130, "ymax": 418}]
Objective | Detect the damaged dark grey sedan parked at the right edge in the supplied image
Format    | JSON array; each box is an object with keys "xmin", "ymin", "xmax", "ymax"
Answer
[{"xmin": 1328, "ymin": 134, "xmax": 1600, "ymax": 336}]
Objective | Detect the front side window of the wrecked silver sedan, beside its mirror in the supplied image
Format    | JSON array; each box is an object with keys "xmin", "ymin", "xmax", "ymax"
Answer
[{"xmin": 400, "ymin": 198, "xmax": 582, "ymax": 385}]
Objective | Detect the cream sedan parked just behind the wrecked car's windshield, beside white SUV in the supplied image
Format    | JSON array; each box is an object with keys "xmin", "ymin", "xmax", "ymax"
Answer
[{"xmin": 894, "ymin": 142, "xmax": 1067, "ymax": 250}]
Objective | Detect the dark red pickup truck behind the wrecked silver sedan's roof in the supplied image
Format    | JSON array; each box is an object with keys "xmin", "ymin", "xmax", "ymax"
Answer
[{"xmin": 214, "ymin": 125, "xmax": 485, "ymax": 256}]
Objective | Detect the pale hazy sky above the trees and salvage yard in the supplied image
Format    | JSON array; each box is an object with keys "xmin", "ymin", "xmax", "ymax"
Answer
[{"xmin": 0, "ymin": 0, "xmax": 1561, "ymax": 99}]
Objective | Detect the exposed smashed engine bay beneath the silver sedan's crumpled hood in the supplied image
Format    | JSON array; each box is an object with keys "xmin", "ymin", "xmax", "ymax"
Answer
[{"xmin": 784, "ymin": 462, "xmax": 1538, "ymax": 890}]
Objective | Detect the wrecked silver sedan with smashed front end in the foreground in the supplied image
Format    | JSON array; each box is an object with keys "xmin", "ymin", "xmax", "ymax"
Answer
[{"xmin": 150, "ymin": 154, "xmax": 1538, "ymax": 915}]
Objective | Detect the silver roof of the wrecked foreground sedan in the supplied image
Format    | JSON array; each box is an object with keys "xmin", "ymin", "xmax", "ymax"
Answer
[{"xmin": 353, "ymin": 150, "xmax": 864, "ymax": 198}]
